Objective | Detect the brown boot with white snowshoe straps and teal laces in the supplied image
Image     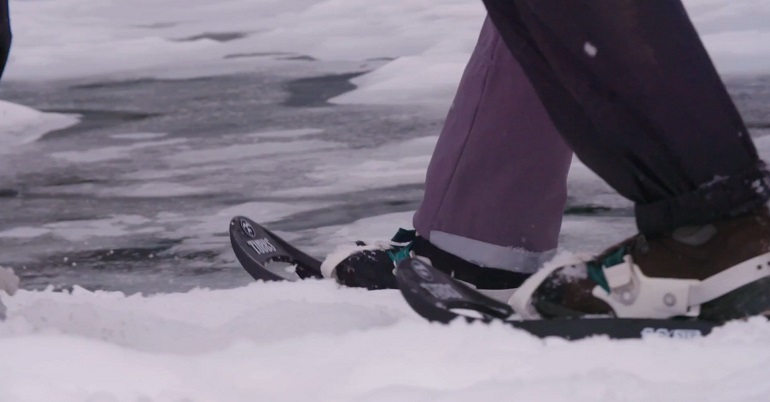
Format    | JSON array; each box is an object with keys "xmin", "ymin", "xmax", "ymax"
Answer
[{"xmin": 511, "ymin": 208, "xmax": 770, "ymax": 322}]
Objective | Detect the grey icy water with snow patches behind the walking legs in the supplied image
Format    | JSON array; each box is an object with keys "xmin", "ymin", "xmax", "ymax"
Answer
[{"xmin": 0, "ymin": 0, "xmax": 770, "ymax": 293}]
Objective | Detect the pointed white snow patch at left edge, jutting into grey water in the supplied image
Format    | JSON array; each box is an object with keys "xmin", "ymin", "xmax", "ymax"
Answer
[{"xmin": 0, "ymin": 100, "xmax": 79, "ymax": 154}]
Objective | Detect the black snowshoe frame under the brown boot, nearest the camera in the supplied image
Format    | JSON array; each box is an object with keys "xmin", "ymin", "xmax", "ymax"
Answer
[{"xmin": 396, "ymin": 258, "xmax": 719, "ymax": 339}]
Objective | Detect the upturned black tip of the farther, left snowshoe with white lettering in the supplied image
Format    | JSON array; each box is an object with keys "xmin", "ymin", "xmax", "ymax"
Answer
[{"xmin": 230, "ymin": 216, "xmax": 323, "ymax": 281}]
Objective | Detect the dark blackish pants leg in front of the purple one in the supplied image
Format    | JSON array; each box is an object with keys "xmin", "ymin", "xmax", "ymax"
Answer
[{"xmin": 484, "ymin": 0, "xmax": 770, "ymax": 234}]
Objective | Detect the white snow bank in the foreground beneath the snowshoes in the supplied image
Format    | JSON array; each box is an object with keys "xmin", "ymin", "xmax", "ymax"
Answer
[{"xmin": 0, "ymin": 281, "xmax": 770, "ymax": 402}]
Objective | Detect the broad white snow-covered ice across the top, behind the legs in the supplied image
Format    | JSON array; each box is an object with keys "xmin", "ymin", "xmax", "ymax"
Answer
[{"xmin": 7, "ymin": 0, "xmax": 770, "ymax": 104}]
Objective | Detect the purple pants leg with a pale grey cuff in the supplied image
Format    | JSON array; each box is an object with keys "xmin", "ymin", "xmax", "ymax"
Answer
[{"xmin": 414, "ymin": 19, "xmax": 572, "ymax": 272}]
